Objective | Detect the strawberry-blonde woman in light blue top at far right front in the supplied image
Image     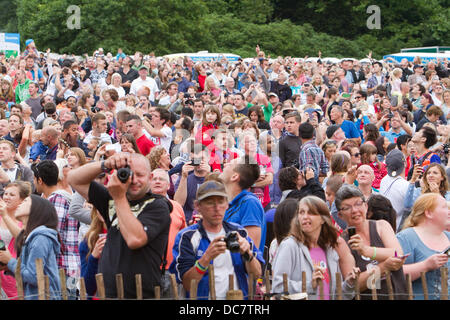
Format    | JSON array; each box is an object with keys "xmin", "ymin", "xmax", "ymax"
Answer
[{"xmin": 397, "ymin": 193, "xmax": 450, "ymax": 300}]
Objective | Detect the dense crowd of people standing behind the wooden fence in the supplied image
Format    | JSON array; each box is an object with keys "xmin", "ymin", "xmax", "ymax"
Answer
[{"xmin": 0, "ymin": 39, "xmax": 450, "ymax": 300}]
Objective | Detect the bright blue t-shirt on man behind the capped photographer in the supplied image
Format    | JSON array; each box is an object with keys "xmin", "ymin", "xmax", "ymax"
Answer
[{"xmin": 223, "ymin": 190, "xmax": 267, "ymax": 254}]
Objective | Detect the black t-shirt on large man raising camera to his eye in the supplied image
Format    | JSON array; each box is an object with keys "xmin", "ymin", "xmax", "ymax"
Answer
[{"xmin": 89, "ymin": 182, "xmax": 173, "ymax": 299}]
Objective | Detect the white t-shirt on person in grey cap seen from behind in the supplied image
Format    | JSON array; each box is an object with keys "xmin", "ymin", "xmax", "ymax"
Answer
[{"xmin": 380, "ymin": 175, "xmax": 409, "ymax": 228}]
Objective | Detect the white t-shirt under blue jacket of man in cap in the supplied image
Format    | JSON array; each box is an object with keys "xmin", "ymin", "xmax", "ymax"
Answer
[{"xmin": 206, "ymin": 228, "xmax": 239, "ymax": 300}]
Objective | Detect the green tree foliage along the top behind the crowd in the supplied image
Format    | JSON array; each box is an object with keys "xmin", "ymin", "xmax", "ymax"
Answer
[{"xmin": 6, "ymin": 0, "xmax": 450, "ymax": 58}]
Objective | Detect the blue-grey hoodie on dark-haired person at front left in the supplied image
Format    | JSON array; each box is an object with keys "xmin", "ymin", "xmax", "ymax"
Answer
[{"xmin": 8, "ymin": 226, "xmax": 61, "ymax": 300}]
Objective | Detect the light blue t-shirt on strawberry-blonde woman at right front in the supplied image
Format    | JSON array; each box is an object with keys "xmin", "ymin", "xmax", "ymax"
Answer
[{"xmin": 397, "ymin": 228, "xmax": 450, "ymax": 300}]
